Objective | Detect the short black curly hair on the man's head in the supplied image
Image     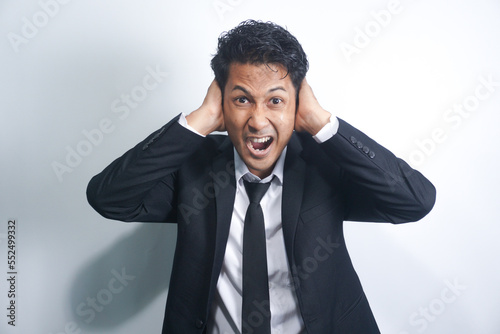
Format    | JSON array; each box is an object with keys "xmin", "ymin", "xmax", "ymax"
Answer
[{"xmin": 211, "ymin": 20, "xmax": 309, "ymax": 98}]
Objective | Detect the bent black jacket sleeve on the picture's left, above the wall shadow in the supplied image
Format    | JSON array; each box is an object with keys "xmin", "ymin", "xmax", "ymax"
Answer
[{"xmin": 87, "ymin": 116, "xmax": 204, "ymax": 222}]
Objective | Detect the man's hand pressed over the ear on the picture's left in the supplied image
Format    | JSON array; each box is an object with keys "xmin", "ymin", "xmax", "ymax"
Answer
[{"xmin": 186, "ymin": 79, "xmax": 225, "ymax": 136}]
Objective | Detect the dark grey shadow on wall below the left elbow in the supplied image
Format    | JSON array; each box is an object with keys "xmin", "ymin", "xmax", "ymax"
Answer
[{"xmin": 70, "ymin": 224, "xmax": 177, "ymax": 330}]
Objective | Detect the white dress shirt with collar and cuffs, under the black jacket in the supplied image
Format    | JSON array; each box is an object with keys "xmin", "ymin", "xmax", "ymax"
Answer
[{"xmin": 179, "ymin": 115, "xmax": 339, "ymax": 334}]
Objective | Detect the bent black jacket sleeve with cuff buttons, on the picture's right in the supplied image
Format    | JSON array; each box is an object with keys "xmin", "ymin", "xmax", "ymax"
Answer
[{"xmin": 321, "ymin": 119, "xmax": 436, "ymax": 223}]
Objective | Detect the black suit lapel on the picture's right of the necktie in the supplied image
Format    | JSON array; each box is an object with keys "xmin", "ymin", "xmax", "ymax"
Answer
[{"xmin": 281, "ymin": 134, "xmax": 306, "ymax": 265}]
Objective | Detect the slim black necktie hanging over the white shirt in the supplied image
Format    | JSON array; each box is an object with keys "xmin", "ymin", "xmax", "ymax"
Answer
[{"xmin": 242, "ymin": 181, "xmax": 271, "ymax": 334}]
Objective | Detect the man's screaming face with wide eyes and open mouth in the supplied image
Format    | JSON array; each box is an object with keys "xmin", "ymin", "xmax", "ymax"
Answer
[{"xmin": 223, "ymin": 63, "xmax": 296, "ymax": 178}]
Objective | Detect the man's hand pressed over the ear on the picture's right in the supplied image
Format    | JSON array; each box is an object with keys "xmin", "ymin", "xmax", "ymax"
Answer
[{"xmin": 295, "ymin": 78, "xmax": 331, "ymax": 136}]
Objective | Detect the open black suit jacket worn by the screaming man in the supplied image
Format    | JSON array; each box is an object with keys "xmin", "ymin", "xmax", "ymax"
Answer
[{"xmin": 87, "ymin": 113, "xmax": 435, "ymax": 334}]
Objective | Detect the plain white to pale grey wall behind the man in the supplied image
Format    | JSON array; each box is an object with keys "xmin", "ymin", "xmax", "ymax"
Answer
[{"xmin": 0, "ymin": 0, "xmax": 500, "ymax": 334}]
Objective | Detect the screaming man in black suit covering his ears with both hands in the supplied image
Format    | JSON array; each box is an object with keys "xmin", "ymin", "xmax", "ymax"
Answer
[{"xmin": 87, "ymin": 21, "xmax": 435, "ymax": 334}]
